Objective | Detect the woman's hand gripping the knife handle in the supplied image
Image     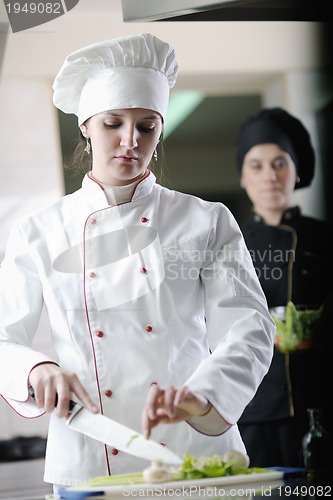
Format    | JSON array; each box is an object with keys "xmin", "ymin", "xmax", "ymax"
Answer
[{"xmin": 29, "ymin": 363, "xmax": 99, "ymax": 418}]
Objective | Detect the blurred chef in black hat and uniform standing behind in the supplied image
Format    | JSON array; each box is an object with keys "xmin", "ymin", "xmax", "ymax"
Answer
[{"xmin": 236, "ymin": 108, "xmax": 333, "ymax": 467}]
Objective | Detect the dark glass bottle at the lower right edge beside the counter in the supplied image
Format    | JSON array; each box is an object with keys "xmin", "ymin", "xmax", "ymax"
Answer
[{"xmin": 302, "ymin": 408, "xmax": 333, "ymax": 487}]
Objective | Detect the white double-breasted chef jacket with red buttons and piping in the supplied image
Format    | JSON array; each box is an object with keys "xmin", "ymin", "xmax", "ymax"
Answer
[{"xmin": 0, "ymin": 173, "xmax": 275, "ymax": 485}]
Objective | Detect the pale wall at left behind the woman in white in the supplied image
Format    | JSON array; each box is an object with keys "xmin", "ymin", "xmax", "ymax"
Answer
[{"xmin": 0, "ymin": 78, "xmax": 63, "ymax": 439}]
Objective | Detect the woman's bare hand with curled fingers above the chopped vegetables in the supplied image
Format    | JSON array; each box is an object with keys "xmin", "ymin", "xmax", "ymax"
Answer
[{"xmin": 141, "ymin": 384, "xmax": 212, "ymax": 438}]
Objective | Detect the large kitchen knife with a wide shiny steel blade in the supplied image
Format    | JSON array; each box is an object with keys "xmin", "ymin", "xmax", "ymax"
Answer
[{"xmin": 29, "ymin": 387, "xmax": 183, "ymax": 465}]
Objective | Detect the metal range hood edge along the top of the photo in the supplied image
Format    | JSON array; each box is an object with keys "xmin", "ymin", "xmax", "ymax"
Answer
[{"xmin": 122, "ymin": 0, "xmax": 328, "ymax": 22}]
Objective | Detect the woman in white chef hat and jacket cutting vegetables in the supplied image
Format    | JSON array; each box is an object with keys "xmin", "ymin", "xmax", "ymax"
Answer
[{"xmin": 0, "ymin": 33, "xmax": 275, "ymax": 485}]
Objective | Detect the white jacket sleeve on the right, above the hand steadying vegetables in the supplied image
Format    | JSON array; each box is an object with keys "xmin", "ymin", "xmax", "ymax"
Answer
[{"xmin": 185, "ymin": 204, "xmax": 275, "ymax": 434}]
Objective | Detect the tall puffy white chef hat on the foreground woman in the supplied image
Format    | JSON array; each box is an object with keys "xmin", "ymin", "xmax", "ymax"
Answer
[{"xmin": 53, "ymin": 33, "xmax": 178, "ymax": 125}]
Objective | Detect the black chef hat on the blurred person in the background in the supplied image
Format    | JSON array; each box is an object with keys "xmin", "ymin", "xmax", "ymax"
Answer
[{"xmin": 236, "ymin": 108, "xmax": 315, "ymax": 189}]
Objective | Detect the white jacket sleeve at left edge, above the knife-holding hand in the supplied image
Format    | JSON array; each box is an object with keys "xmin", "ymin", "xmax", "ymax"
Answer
[{"xmin": 0, "ymin": 225, "xmax": 54, "ymax": 417}]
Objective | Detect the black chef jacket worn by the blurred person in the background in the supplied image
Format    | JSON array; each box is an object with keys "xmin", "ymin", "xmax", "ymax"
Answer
[{"xmin": 239, "ymin": 207, "xmax": 333, "ymax": 424}]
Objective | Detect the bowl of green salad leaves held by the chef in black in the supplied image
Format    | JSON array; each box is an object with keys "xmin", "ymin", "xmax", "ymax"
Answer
[{"xmin": 271, "ymin": 301, "xmax": 323, "ymax": 352}]
